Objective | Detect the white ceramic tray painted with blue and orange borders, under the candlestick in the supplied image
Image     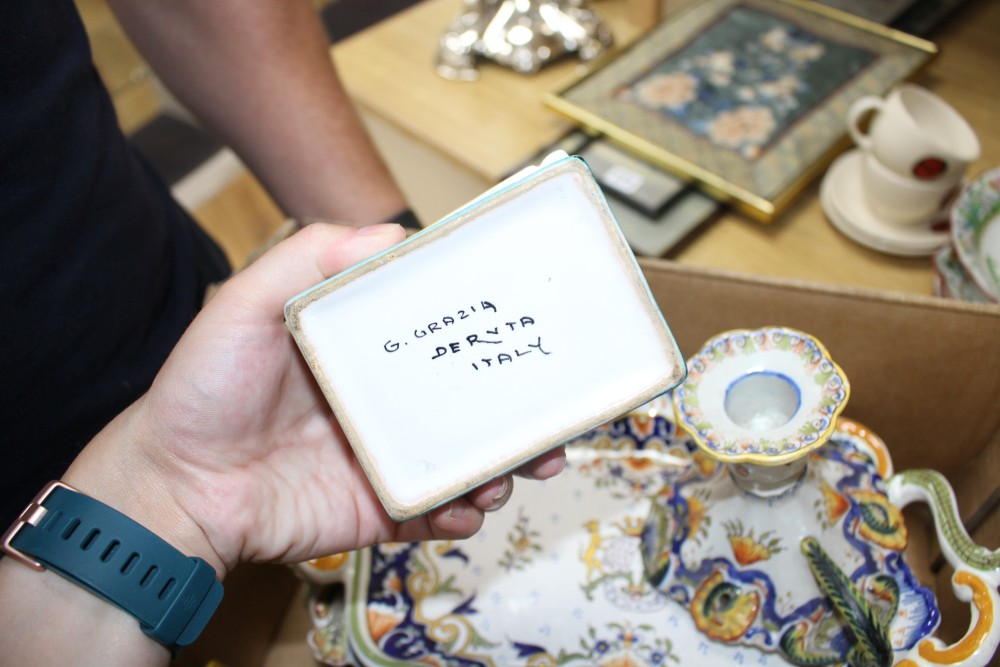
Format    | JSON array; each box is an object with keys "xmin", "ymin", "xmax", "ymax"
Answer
[{"xmin": 298, "ymin": 399, "xmax": 992, "ymax": 667}]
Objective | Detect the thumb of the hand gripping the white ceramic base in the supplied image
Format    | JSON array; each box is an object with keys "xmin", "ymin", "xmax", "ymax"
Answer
[{"xmin": 223, "ymin": 223, "xmax": 406, "ymax": 318}]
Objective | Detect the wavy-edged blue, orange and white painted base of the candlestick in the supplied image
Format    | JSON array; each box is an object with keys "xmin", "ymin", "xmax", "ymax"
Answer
[{"xmin": 643, "ymin": 420, "xmax": 939, "ymax": 664}]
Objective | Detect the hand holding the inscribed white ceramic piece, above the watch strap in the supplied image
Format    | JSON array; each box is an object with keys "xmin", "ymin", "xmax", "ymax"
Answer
[{"xmin": 64, "ymin": 224, "xmax": 565, "ymax": 574}]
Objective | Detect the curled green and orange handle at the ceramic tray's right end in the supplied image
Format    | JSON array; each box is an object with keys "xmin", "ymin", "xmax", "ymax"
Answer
[{"xmin": 886, "ymin": 470, "xmax": 1000, "ymax": 667}]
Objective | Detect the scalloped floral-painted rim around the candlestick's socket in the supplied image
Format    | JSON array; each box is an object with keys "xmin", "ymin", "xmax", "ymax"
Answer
[{"xmin": 673, "ymin": 326, "xmax": 850, "ymax": 466}]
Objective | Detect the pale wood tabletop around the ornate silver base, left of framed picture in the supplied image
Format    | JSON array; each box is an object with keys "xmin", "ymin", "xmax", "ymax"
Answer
[{"xmin": 333, "ymin": 0, "xmax": 639, "ymax": 183}]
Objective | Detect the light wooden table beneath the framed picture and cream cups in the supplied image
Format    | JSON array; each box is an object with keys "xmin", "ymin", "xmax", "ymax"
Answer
[{"xmin": 333, "ymin": 0, "xmax": 1000, "ymax": 294}]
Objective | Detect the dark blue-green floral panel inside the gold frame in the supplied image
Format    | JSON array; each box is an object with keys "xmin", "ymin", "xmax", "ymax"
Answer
[{"xmin": 617, "ymin": 6, "xmax": 876, "ymax": 160}]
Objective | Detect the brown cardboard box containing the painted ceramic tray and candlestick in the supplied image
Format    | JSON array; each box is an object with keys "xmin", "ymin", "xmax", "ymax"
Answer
[{"xmin": 182, "ymin": 260, "xmax": 1000, "ymax": 667}]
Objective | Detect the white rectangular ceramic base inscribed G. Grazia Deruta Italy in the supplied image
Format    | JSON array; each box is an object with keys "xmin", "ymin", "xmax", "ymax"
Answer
[{"xmin": 286, "ymin": 158, "xmax": 686, "ymax": 520}]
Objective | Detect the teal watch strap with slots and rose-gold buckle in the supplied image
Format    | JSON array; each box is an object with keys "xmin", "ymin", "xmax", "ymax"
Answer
[{"xmin": 3, "ymin": 482, "xmax": 222, "ymax": 651}]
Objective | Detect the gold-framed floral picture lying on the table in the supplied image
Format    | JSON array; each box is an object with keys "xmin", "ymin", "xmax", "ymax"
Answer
[{"xmin": 545, "ymin": 0, "xmax": 937, "ymax": 222}]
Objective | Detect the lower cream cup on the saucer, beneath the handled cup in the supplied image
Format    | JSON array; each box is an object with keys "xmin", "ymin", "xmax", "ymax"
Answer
[{"xmin": 861, "ymin": 151, "xmax": 962, "ymax": 226}]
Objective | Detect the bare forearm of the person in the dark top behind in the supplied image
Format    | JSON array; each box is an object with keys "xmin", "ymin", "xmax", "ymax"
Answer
[{"xmin": 109, "ymin": 0, "xmax": 406, "ymax": 225}]
